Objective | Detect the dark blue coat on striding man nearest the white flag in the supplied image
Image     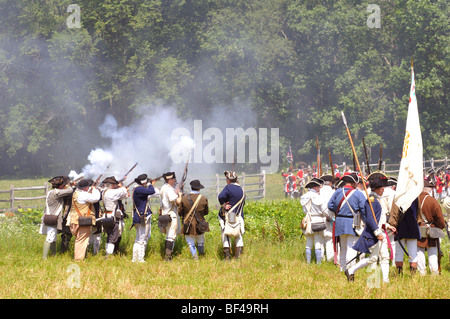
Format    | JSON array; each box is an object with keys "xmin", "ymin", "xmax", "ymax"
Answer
[{"xmin": 352, "ymin": 197, "xmax": 382, "ymax": 254}]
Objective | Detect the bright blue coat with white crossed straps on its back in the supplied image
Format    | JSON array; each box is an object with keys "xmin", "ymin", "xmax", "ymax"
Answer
[{"xmin": 328, "ymin": 186, "xmax": 366, "ymax": 237}]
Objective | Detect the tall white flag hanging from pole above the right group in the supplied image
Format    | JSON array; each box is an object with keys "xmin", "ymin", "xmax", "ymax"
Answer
[{"xmin": 395, "ymin": 67, "xmax": 424, "ymax": 211}]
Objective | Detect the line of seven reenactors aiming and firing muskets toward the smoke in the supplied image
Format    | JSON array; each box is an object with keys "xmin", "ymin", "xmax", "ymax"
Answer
[{"xmin": 39, "ymin": 171, "xmax": 245, "ymax": 262}]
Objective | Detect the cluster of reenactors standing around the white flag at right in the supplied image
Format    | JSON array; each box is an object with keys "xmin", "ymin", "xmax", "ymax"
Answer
[{"xmin": 300, "ymin": 171, "xmax": 450, "ymax": 283}]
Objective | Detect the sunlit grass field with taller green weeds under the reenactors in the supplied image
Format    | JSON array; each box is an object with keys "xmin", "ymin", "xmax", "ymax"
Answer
[{"xmin": 0, "ymin": 175, "xmax": 450, "ymax": 300}]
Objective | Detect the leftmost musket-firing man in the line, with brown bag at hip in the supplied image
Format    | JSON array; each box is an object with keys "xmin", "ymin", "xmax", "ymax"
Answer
[{"xmin": 39, "ymin": 176, "xmax": 73, "ymax": 259}]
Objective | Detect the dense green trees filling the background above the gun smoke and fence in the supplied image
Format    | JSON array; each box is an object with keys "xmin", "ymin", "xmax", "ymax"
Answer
[{"xmin": 0, "ymin": 0, "xmax": 450, "ymax": 176}]
